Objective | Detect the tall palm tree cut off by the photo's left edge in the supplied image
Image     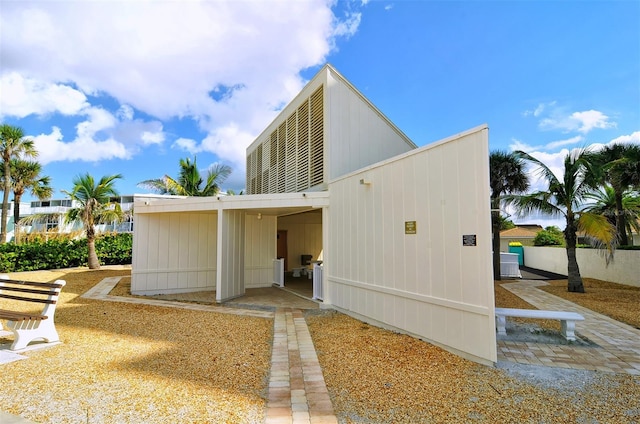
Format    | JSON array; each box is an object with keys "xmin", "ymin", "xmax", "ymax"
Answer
[{"xmin": 0, "ymin": 124, "xmax": 38, "ymax": 243}]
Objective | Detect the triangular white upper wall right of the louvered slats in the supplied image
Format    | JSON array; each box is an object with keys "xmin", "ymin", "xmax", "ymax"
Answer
[{"xmin": 325, "ymin": 69, "xmax": 415, "ymax": 180}]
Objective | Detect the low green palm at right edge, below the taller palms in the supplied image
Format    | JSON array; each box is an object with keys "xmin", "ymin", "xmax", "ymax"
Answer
[{"xmin": 585, "ymin": 185, "xmax": 640, "ymax": 244}]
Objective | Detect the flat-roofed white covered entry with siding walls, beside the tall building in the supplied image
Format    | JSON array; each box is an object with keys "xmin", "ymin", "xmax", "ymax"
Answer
[{"xmin": 131, "ymin": 191, "xmax": 329, "ymax": 303}]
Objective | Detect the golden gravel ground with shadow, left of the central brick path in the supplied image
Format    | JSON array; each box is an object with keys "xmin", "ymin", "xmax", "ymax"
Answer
[{"xmin": 0, "ymin": 271, "xmax": 273, "ymax": 424}]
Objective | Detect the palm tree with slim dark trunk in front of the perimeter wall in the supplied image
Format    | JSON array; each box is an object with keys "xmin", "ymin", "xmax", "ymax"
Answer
[{"xmin": 504, "ymin": 149, "xmax": 617, "ymax": 293}]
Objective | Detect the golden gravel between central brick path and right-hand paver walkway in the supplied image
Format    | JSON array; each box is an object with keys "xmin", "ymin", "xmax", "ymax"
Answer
[{"xmin": 306, "ymin": 311, "xmax": 640, "ymax": 423}]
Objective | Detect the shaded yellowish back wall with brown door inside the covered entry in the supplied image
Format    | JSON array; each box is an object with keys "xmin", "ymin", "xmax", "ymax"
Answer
[{"xmin": 278, "ymin": 210, "xmax": 323, "ymax": 270}]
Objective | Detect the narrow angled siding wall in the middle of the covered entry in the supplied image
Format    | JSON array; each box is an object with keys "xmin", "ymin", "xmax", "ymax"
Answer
[{"xmin": 216, "ymin": 210, "xmax": 245, "ymax": 302}]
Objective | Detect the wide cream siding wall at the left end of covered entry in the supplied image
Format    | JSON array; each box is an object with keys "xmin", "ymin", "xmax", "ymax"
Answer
[{"xmin": 131, "ymin": 213, "xmax": 217, "ymax": 295}]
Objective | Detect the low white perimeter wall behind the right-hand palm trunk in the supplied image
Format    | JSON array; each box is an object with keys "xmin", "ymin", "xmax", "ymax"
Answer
[{"xmin": 524, "ymin": 246, "xmax": 640, "ymax": 287}]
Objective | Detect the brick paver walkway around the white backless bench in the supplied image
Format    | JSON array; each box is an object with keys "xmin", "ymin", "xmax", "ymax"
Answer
[{"xmin": 498, "ymin": 280, "xmax": 640, "ymax": 375}]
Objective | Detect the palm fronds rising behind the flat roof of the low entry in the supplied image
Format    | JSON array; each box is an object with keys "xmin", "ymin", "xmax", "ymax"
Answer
[{"xmin": 138, "ymin": 158, "xmax": 231, "ymax": 196}]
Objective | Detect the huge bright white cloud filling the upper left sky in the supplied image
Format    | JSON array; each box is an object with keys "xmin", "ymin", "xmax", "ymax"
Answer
[{"xmin": 0, "ymin": 0, "xmax": 366, "ymax": 173}]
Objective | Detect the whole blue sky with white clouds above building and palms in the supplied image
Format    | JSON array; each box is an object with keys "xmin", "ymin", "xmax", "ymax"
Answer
[{"xmin": 0, "ymin": 0, "xmax": 640, "ymax": 229}]
